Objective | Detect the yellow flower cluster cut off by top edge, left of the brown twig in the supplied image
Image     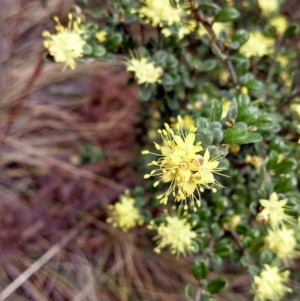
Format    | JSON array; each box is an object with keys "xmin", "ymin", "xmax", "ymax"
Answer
[{"xmin": 139, "ymin": 0, "xmax": 186, "ymax": 27}]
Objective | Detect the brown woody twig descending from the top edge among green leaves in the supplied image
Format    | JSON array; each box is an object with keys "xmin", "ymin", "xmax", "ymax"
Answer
[{"xmin": 189, "ymin": 0, "xmax": 238, "ymax": 86}]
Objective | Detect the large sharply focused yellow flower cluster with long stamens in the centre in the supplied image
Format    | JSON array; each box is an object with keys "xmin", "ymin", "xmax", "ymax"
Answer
[{"xmin": 142, "ymin": 116, "xmax": 223, "ymax": 211}]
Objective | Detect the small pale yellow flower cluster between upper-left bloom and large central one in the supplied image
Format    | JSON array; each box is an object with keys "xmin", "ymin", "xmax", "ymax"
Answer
[{"xmin": 127, "ymin": 57, "xmax": 163, "ymax": 85}]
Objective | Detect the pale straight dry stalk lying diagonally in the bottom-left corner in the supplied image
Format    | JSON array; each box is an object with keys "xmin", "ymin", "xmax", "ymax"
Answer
[{"xmin": 0, "ymin": 222, "xmax": 86, "ymax": 301}]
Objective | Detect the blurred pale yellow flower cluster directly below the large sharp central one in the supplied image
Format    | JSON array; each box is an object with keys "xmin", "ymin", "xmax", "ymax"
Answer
[{"xmin": 149, "ymin": 211, "xmax": 197, "ymax": 256}]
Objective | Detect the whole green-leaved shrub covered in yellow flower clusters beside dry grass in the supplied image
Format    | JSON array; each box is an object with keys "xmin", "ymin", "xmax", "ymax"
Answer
[{"xmin": 43, "ymin": 0, "xmax": 300, "ymax": 301}]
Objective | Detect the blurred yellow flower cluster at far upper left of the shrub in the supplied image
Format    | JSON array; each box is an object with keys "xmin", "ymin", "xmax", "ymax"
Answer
[{"xmin": 43, "ymin": 14, "xmax": 85, "ymax": 69}]
